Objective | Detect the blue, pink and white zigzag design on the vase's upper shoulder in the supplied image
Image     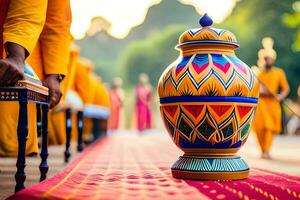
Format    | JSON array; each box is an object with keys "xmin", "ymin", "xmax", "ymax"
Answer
[{"xmin": 161, "ymin": 54, "xmax": 255, "ymax": 95}]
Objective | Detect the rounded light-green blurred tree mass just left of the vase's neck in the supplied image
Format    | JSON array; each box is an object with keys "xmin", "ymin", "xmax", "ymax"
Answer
[{"xmin": 119, "ymin": 25, "xmax": 187, "ymax": 85}]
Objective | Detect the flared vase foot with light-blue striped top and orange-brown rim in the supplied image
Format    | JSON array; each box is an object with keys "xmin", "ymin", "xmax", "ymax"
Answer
[{"xmin": 172, "ymin": 156, "xmax": 249, "ymax": 180}]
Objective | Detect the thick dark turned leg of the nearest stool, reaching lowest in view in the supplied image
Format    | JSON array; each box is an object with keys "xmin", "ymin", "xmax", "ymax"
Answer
[{"xmin": 15, "ymin": 101, "xmax": 28, "ymax": 192}]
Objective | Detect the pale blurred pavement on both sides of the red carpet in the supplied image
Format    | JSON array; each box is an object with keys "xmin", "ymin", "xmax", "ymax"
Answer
[{"xmin": 0, "ymin": 130, "xmax": 300, "ymax": 199}]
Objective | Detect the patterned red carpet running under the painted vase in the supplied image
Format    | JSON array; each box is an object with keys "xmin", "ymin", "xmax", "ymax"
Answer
[{"xmin": 9, "ymin": 135, "xmax": 300, "ymax": 200}]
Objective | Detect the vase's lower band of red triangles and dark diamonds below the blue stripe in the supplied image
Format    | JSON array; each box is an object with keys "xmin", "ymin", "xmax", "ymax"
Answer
[{"xmin": 160, "ymin": 102, "xmax": 256, "ymax": 148}]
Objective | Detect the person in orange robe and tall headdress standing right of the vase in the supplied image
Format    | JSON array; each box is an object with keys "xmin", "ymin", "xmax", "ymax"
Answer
[{"xmin": 252, "ymin": 37, "xmax": 290, "ymax": 159}]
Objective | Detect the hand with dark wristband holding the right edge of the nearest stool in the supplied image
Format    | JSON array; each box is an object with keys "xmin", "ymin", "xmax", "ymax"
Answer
[{"xmin": 43, "ymin": 74, "xmax": 62, "ymax": 108}]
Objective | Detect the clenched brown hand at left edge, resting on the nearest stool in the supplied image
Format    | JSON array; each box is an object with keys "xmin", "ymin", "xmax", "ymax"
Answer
[{"xmin": 0, "ymin": 58, "xmax": 24, "ymax": 86}]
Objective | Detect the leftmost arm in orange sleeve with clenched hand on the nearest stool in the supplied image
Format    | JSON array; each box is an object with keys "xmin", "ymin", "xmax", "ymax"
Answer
[{"xmin": 0, "ymin": 0, "xmax": 47, "ymax": 85}]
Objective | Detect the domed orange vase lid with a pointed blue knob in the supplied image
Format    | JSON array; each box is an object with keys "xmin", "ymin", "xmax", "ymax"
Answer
[{"xmin": 176, "ymin": 14, "xmax": 239, "ymax": 49}]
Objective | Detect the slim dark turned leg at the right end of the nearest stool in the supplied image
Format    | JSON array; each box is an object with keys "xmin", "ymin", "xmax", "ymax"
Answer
[{"xmin": 39, "ymin": 105, "xmax": 49, "ymax": 181}]
